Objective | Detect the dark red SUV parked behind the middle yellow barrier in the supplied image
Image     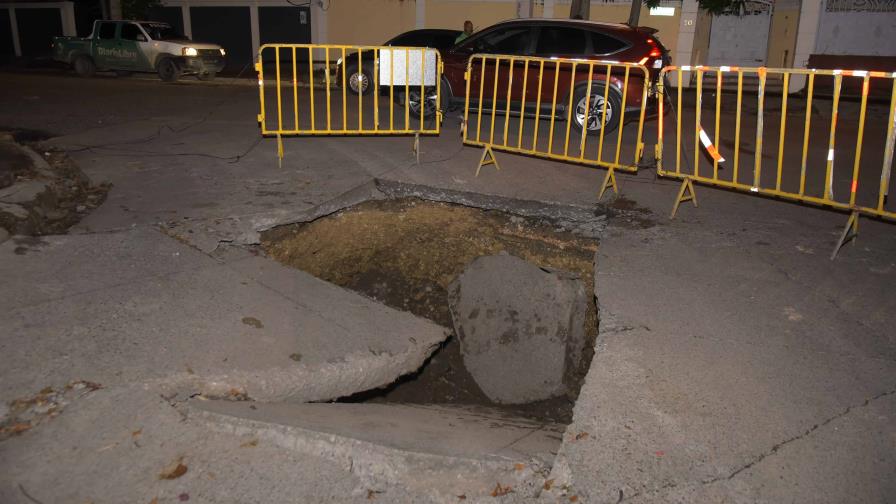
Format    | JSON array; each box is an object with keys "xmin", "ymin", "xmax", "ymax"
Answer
[{"xmin": 442, "ymin": 19, "xmax": 669, "ymax": 134}]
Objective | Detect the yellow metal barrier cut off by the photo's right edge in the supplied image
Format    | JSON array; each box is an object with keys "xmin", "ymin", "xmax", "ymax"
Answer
[{"xmin": 656, "ymin": 66, "xmax": 896, "ymax": 259}]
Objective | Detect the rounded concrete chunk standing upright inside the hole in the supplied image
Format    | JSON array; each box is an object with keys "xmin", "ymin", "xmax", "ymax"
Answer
[{"xmin": 449, "ymin": 255, "xmax": 588, "ymax": 404}]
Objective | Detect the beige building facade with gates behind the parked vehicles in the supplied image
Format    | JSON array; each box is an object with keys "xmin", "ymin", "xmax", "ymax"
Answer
[{"xmin": 0, "ymin": 0, "xmax": 896, "ymax": 79}]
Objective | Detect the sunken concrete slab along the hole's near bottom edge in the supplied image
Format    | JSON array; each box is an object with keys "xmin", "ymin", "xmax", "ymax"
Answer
[{"xmin": 189, "ymin": 401, "xmax": 562, "ymax": 502}]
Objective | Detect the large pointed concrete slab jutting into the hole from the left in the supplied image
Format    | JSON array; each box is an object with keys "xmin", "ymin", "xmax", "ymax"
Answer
[{"xmin": 0, "ymin": 229, "xmax": 447, "ymax": 400}]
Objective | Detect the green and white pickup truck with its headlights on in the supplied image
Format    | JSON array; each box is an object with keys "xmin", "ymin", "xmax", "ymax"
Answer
[{"xmin": 53, "ymin": 21, "xmax": 224, "ymax": 82}]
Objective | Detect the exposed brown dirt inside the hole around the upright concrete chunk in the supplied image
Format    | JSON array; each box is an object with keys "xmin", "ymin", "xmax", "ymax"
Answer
[{"xmin": 262, "ymin": 199, "xmax": 597, "ymax": 423}]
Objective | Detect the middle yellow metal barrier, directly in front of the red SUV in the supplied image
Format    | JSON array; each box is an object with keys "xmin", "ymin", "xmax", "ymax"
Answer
[{"xmin": 464, "ymin": 54, "xmax": 650, "ymax": 198}]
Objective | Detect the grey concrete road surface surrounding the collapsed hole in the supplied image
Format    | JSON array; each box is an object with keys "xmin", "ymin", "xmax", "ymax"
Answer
[{"xmin": 0, "ymin": 75, "xmax": 896, "ymax": 503}]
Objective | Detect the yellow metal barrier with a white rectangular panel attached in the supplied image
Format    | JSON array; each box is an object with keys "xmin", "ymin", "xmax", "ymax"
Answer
[{"xmin": 255, "ymin": 44, "xmax": 442, "ymax": 163}]
